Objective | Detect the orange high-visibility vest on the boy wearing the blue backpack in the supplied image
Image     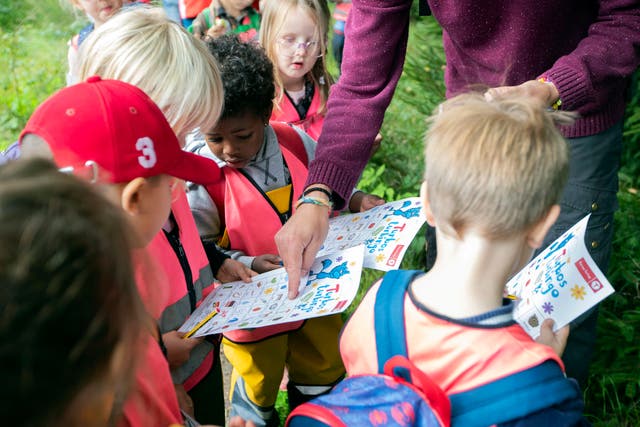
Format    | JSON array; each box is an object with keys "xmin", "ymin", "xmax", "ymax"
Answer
[{"xmin": 340, "ymin": 286, "xmax": 564, "ymax": 394}]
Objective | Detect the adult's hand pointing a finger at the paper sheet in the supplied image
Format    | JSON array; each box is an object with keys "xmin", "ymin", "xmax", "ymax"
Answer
[{"xmin": 275, "ymin": 203, "xmax": 329, "ymax": 299}]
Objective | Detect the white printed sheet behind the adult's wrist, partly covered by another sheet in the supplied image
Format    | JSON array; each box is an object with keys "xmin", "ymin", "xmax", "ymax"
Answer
[{"xmin": 319, "ymin": 197, "xmax": 425, "ymax": 271}]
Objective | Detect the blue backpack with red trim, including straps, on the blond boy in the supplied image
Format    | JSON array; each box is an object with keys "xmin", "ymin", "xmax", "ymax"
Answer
[{"xmin": 286, "ymin": 270, "xmax": 580, "ymax": 427}]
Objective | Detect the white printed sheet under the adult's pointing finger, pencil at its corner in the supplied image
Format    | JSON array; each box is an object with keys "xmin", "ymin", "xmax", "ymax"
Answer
[{"xmin": 179, "ymin": 245, "xmax": 364, "ymax": 337}]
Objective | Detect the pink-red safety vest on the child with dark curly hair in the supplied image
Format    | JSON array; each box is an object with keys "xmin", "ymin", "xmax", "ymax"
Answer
[{"xmin": 209, "ymin": 127, "xmax": 308, "ymax": 342}]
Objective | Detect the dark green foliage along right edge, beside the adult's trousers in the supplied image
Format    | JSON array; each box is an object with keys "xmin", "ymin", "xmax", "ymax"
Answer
[{"xmin": 585, "ymin": 73, "xmax": 640, "ymax": 426}]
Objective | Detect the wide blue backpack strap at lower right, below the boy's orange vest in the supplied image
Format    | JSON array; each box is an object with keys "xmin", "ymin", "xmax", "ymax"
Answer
[{"xmin": 449, "ymin": 360, "xmax": 581, "ymax": 427}]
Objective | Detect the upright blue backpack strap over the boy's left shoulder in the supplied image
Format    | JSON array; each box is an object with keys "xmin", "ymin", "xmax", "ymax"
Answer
[{"xmin": 373, "ymin": 270, "xmax": 423, "ymax": 374}]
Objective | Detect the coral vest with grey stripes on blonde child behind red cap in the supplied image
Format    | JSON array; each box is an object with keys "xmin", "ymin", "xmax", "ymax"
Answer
[{"xmin": 149, "ymin": 194, "xmax": 214, "ymax": 390}]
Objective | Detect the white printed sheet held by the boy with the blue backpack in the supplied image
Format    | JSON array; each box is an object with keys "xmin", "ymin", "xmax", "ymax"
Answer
[{"xmin": 506, "ymin": 215, "xmax": 614, "ymax": 339}]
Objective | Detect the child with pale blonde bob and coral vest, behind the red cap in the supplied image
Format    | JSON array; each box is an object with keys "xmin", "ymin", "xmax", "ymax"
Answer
[{"xmin": 80, "ymin": 8, "xmax": 255, "ymax": 425}]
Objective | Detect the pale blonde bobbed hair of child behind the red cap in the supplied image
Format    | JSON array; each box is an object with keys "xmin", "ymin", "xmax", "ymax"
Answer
[{"xmin": 80, "ymin": 6, "xmax": 224, "ymax": 142}]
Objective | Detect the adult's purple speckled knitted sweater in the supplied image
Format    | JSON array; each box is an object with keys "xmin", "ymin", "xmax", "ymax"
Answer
[{"xmin": 307, "ymin": 0, "xmax": 640, "ymax": 207}]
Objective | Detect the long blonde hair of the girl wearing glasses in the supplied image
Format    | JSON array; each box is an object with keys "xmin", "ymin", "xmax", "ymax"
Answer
[{"xmin": 260, "ymin": 0, "xmax": 333, "ymax": 114}]
